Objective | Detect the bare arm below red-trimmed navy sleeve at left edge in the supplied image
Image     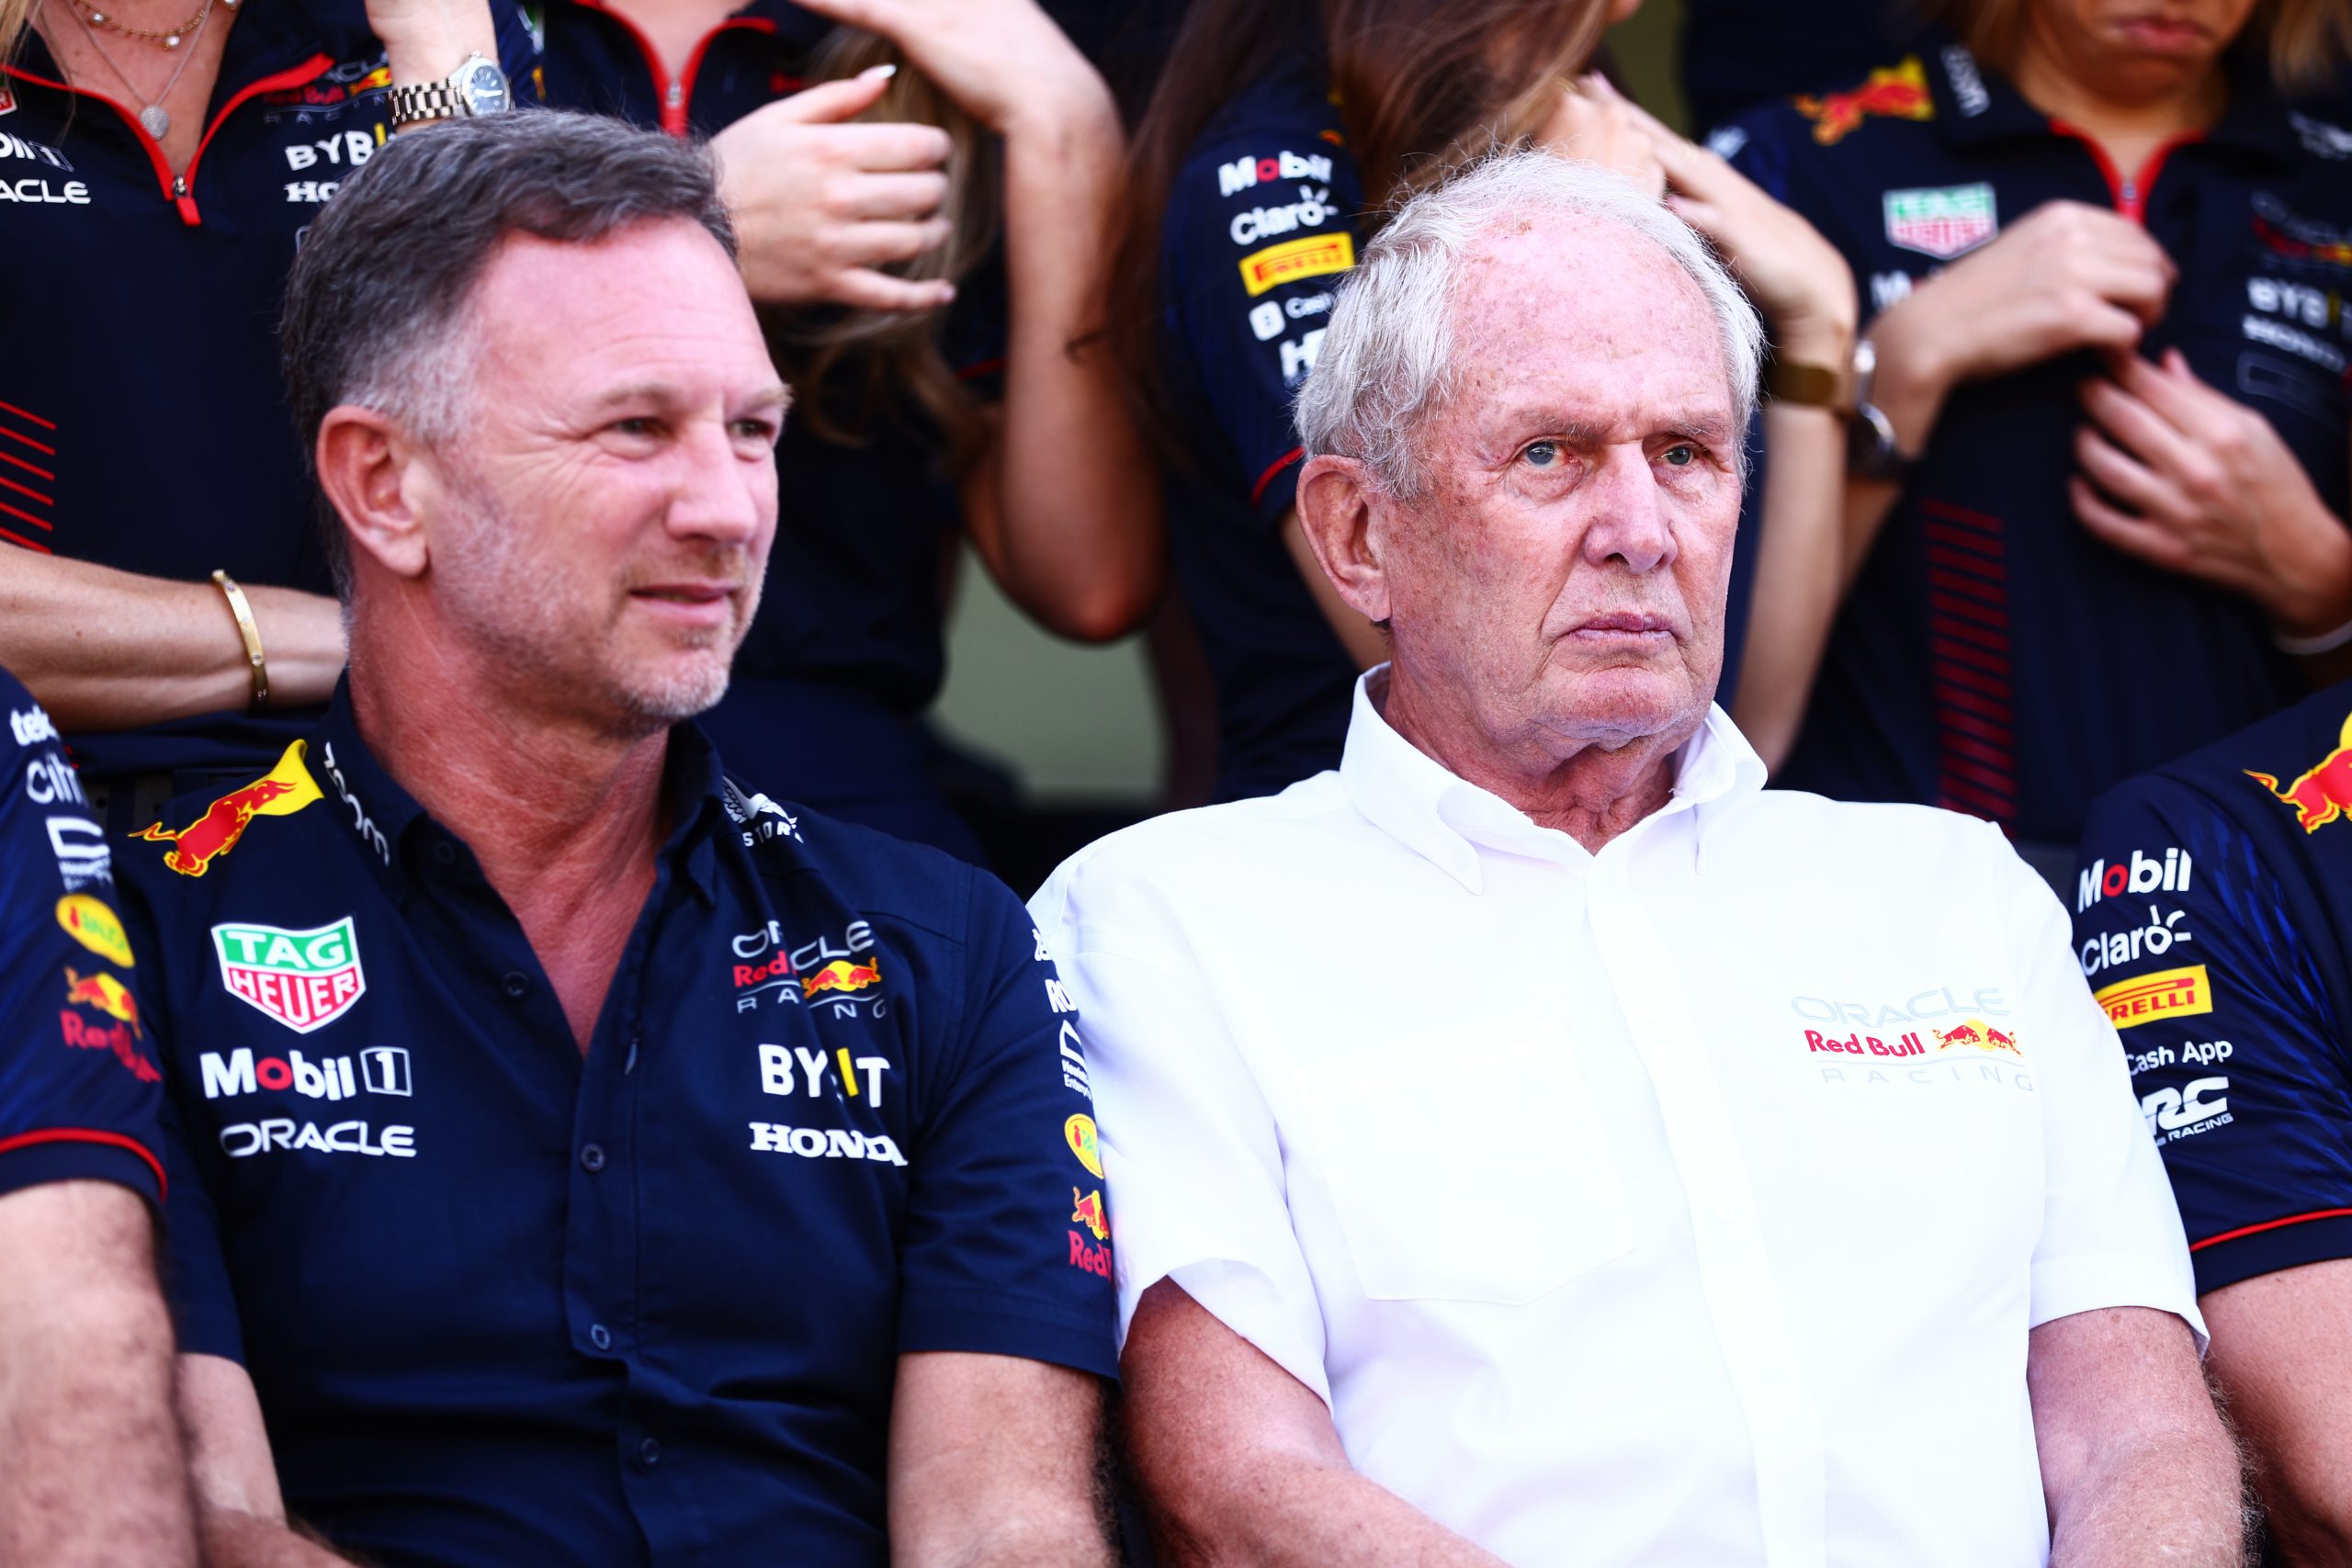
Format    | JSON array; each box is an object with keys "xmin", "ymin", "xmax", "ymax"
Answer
[{"xmin": 0, "ymin": 1182, "xmax": 195, "ymax": 1568}]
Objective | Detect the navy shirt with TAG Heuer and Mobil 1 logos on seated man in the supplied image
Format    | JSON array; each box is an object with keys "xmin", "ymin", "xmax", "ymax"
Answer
[{"xmin": 118, "ymin": 696, "xmax": 1114, "ymax": 1568}]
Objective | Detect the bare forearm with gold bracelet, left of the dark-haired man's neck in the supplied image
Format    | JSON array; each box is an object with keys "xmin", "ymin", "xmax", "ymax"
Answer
[{"xmin": 0, "ymin": 550, "xmax": 344, "ymax": 731}]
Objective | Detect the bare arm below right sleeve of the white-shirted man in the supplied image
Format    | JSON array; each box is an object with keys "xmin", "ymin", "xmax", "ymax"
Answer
[{"xmin": 2025, "ymin": 1307, "xmax": 2246, "ymax": 1568}]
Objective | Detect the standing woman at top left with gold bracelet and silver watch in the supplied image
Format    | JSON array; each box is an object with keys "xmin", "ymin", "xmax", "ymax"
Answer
[{"xmin": 0, "ymin": 0, "xmax": 534, "ymax": 829}]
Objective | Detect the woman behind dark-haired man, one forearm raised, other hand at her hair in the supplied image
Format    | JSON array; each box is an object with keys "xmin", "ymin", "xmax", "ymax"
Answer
[{"xmin": 546, "ymin": 0, "xmax": 1162, "ymax": 858}]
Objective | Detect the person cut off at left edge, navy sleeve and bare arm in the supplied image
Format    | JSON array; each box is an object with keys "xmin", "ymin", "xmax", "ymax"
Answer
[{"xmin": 0, "ymin": 670, "xmax": 195, "ymax": 1568}]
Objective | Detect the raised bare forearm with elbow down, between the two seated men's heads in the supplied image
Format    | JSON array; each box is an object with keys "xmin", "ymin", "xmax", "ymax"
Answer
[{"xmin": 974, "ymin": 76, "xmax": 1162, "ymax": 639}]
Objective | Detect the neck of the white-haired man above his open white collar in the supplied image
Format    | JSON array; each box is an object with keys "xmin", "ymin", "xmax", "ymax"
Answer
[{"xmin": 1376, "ymin": 672, "xmax": 1696, "ymax": 853}]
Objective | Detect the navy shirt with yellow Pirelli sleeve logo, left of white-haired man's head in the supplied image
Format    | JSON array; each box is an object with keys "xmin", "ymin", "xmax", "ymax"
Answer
[{"xmin": 1159, "ymin": 51, "xmax": 1364, "ymax": 799}]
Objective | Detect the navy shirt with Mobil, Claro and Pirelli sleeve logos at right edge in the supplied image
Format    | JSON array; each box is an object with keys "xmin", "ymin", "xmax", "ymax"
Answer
[{"xmin": 2075, "ymin": 686, "xmax": 2352, "ymax": 1291}]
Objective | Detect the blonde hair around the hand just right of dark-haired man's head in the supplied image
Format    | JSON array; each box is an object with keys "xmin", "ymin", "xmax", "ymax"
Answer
[{"xmin": 762, "ymin": 30, "xmax": 1004, "ymax": 475}]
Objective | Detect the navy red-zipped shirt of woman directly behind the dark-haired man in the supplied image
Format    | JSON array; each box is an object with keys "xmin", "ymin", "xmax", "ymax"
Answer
[{"xmin": 541, "ymin": 0, "xmax": 1004, "ymax": 861}]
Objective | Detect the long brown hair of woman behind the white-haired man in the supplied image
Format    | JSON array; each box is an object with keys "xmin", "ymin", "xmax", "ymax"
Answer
[{"xmin": 1105, "ymin": 0, "xmax": 1609, "ymax": 434}]
